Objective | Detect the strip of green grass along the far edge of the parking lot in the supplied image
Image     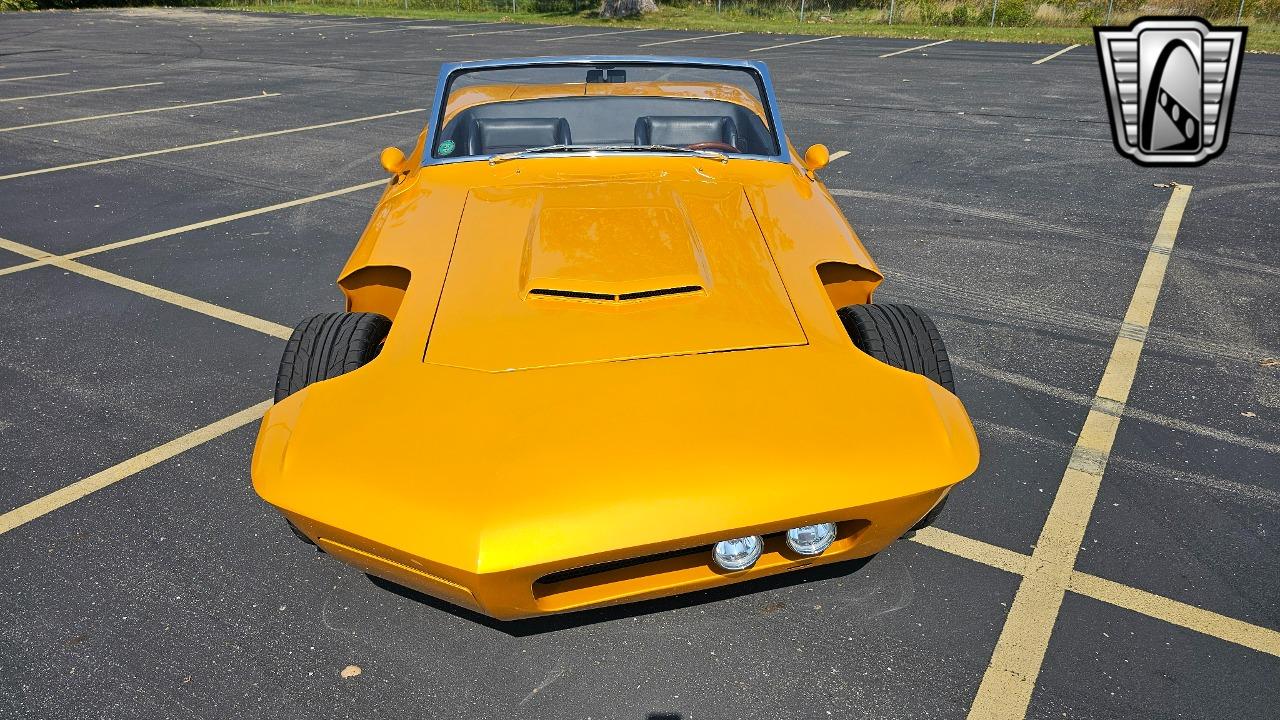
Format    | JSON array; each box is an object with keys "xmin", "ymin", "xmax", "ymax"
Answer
[{"xmin": 223, "ymin": 0, "xmax": 1280, "ymax": 53}]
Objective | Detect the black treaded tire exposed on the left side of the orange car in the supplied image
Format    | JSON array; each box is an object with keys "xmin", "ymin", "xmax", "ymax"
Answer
[{"xmin": 275, "ymin": 313, "xmax": 392, "ymax": 402}]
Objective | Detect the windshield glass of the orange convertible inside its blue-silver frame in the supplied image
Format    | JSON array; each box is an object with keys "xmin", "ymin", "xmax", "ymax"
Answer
[{"xmin": 431, "ymin": 63, "xmax": 780, "ymax": 159}]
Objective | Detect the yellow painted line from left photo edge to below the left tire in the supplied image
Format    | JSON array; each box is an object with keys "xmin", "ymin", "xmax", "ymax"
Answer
[{"xmin": 0, "ymin": 400, "xmax": 271, "ymax": 534}]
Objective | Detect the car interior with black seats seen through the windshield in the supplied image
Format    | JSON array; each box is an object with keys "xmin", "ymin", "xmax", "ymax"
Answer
[{"xmin": 434, "ymin": 96, "xmax": 778, "ymax": 158}]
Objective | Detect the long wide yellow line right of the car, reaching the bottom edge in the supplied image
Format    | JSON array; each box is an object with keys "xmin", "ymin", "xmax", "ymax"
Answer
[{"xmin": 969, "ymin": 184, "xmax": 1192, "ymax": 720}]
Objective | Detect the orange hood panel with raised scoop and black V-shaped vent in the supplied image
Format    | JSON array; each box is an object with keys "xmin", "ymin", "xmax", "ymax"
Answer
[{"xmin": 425, "ymin": 179, "xmax": 805, "ymax": 372}]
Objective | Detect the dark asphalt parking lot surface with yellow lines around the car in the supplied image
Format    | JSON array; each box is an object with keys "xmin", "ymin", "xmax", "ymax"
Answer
[{"xmin": 0, "ymin": 9, "xmax": 1280, "ymax": 720}]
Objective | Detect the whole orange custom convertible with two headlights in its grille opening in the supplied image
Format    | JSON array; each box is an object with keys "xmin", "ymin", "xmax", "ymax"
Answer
[{"xmin": 252, "ymin": 56, "xmax": 978, "ymax": 619}]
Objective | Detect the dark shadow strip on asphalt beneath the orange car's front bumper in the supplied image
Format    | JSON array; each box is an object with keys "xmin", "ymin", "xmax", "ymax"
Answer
[{"xmin": 365, "ymin": 555, "xmax": 874, "ymax": 635}]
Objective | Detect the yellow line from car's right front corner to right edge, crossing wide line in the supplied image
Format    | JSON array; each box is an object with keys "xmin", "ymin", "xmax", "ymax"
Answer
[{"xmin": 911, "ymin": 520, "xmax": 1280, "ymax": 657}]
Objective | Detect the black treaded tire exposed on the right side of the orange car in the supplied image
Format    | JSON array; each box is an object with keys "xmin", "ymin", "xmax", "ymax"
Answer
[{"xmin": 838, "ymin": 305, "xmax": 956, "ymax": 393}]
